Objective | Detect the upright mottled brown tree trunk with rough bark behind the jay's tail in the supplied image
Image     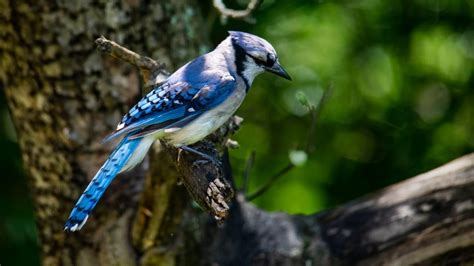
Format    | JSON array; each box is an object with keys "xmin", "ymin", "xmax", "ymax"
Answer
[{"xmin": 0, "ymin": 0, "xmax": 208, "ymax": 265}]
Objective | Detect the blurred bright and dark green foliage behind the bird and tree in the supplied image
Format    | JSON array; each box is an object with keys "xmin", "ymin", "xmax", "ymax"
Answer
[{"xmin": 0, "ymin": 0, "xmax": 474, "ymax": 265}]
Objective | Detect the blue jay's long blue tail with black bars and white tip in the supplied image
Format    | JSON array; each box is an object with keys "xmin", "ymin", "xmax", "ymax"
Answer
[{"xmin": 64, "ymin": 135, "xmax": 155, "ymax": 231}]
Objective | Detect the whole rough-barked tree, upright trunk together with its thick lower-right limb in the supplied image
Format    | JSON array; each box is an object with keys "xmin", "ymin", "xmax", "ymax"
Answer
[{"xmin": 0, "ymin": 0, "xmax": 474, "ymax": 265}]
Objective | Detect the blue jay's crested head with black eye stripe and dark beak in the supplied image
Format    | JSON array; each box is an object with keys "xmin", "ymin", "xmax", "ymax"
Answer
[{"xmin": 225, "ymin": 31, "xmax": 291, "ymax": 83}]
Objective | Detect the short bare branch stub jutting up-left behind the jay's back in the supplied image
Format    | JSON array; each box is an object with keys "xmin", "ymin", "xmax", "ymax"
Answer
[{"xmin": 95, "ymin": 36, "xmax": 169, "ymax": 86}]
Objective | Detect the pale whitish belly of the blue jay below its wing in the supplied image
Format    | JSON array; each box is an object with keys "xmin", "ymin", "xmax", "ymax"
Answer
[{"xmin": 164, "ymin": 86, "xmax": 245, "ymax": 147}]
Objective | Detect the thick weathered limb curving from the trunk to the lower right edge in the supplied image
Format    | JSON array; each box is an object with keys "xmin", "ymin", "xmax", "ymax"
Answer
[{"xmin": 193, "ymin": 154, "xmax": 474, "ymax": 265}]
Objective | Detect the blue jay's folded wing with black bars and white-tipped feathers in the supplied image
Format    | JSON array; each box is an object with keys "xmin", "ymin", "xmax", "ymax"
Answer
[{"xmin": 104, "ymin": 73, "xmax": 236, "ymax": 142}]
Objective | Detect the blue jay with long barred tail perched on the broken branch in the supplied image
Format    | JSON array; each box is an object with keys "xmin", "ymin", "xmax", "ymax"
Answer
[{"xmin": 64, "ymin": 31, "xmax": 291, "ymax": 231}]
